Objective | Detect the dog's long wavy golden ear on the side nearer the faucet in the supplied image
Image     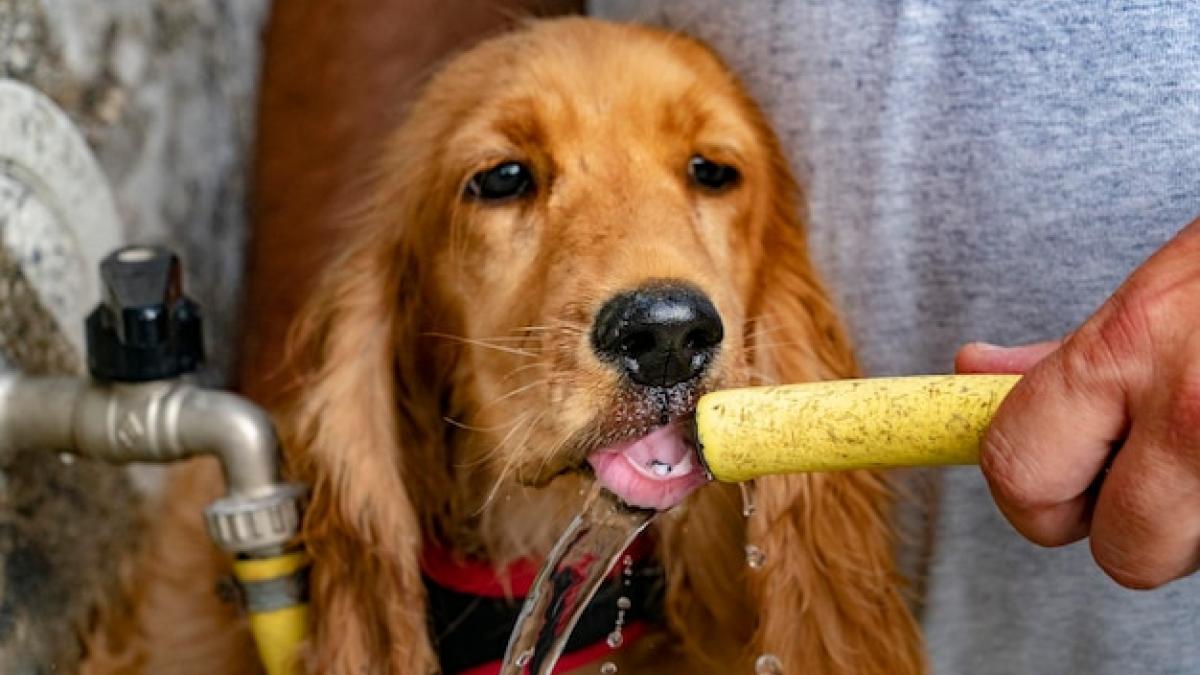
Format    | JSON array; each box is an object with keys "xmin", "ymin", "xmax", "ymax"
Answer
[{"xmin": 286, "ymin": 154, "xmax": 451, "ymax": 675}]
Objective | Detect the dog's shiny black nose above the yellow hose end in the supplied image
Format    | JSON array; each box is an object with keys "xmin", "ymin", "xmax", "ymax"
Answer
[{"xmin": 592, "ymin": 283, "xmax": 725, "ymax": 387}]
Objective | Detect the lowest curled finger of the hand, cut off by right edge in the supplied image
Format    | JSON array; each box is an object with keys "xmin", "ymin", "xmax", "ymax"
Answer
[{"xmin": 1091, "ymin": 395, "xmax": 1200, "ymax": 589}]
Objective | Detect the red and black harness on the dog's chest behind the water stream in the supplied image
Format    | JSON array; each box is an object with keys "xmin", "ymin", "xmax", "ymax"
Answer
[{"xmin": 421, "ymin": 539, "xmax": 664, "ymax": 675}]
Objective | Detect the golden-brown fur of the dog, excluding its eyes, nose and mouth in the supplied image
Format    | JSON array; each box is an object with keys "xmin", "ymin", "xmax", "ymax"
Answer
[{"xmin": 87, "ymin": 19, "xmax": 924, "ymax": 675}]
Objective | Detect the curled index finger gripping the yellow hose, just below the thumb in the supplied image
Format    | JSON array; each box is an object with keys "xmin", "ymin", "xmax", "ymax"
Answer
[{"xmin": 980, "ymin": 341, "xmax": 1127, "ymax": 546}]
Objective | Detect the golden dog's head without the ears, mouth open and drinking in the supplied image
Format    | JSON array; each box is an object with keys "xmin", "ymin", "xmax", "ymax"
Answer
[{"xmin": 348, "ymin": 22, "xmax": 844, "ymax": 508}]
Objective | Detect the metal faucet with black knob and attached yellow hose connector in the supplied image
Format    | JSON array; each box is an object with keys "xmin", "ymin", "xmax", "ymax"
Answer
[{"xmin": 0, "ymin": 246, "xmax": 307, "ymax": 674}]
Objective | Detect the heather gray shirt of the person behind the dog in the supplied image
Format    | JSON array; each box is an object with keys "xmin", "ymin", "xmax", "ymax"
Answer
[{"xmin": 592, "ymin": 0, "xmax": 1200, "ymax": 675}]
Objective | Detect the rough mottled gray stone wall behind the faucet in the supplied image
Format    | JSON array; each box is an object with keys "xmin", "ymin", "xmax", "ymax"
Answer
[{"xmin": 0, "ymin": 0, "xmax": 268, "ymax": 675}]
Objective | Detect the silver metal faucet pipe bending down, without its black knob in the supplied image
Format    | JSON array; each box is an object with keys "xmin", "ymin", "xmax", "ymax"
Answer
[{"xmin": 0, "ymin": 372, "xmax": 305, "ymax": 556}]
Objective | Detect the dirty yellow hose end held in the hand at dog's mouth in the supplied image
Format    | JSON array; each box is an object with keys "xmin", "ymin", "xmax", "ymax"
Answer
[{"xmin": 696, "ymin": 375, "xmax": 1019, "ymax": 482}]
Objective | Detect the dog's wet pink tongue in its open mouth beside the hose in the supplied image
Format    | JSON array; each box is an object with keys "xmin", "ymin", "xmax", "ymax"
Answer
[{"xmin": 588, "ymin": 425, "xmax": 707, "ymax": 509}]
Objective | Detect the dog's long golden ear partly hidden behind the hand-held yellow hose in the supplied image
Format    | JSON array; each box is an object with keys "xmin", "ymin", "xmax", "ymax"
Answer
[{"xmin": 748, "ymin": 138, "xmax": 925, "ymax": 675}]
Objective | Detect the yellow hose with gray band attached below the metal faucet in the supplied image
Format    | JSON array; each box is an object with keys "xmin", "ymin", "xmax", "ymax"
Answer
[{"xmin": 234, "ymin": 552, "xmax": 308, "ymax": 675}]
